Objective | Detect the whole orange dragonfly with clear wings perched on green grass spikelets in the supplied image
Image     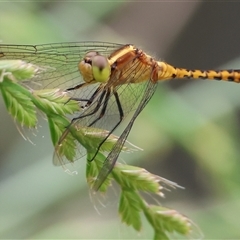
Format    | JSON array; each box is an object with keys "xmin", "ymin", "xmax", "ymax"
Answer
[{"xmin": 0, "ymin": 42, "xmax": 240, "ymax": 190}]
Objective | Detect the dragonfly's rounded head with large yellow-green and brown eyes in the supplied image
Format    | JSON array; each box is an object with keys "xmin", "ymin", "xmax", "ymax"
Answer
[{"xmin": 78, "ymin": 52, "xmax": 111, "ymax": 83}]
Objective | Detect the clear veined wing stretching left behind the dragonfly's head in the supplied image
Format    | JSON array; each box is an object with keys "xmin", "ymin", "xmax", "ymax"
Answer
[{"xmin": 0, "ymin": 42, "xmax": 123, "ymax": 90}]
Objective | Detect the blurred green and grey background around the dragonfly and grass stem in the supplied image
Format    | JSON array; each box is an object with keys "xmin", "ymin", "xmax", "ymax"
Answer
[{"xmin": 0, "ymin": 1, "xmax": 240, "ymax": 239}]
